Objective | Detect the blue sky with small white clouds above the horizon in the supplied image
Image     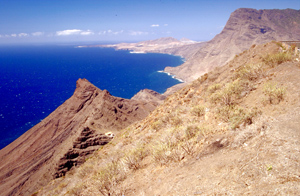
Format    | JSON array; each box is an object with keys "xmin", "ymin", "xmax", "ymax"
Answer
[{"xmin": 0, "ymin": 0, "xmax": 300, "ymax": 44}]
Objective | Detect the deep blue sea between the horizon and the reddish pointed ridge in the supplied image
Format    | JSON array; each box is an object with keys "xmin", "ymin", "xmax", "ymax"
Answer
[{"xmin": 0, "ymin": 45, "xmax": 183, "ymax": 149}]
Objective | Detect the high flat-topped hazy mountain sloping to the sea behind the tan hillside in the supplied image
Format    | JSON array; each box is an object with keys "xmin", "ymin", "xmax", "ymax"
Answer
[{"xmin": 165, "ymin": 8, "xmax": 300, "ymax": 81}]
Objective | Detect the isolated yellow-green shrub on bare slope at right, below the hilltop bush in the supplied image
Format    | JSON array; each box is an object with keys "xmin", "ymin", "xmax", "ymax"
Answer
[{"xmin": 263, "ymin": 82, "xmax": 286, "ymax": 104}]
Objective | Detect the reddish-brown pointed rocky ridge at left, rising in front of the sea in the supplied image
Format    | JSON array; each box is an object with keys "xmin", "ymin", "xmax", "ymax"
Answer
[{"xmin": 0, "ymin": 79, "xmax": 157, "ymax": 195}]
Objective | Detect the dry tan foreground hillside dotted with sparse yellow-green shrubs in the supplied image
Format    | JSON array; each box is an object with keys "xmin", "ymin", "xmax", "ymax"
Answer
[{"xmin": 36, "ymin": 42, "xmax": 300, "ymax": 195}]
